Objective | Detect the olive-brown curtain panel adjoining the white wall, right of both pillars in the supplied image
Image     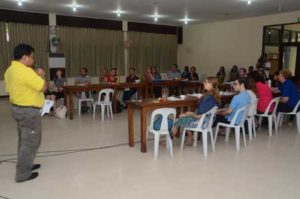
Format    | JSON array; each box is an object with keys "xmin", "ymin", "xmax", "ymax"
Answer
[{"xmin": 128, "ymin": 32, "xmax": 177, "ymax": 74}]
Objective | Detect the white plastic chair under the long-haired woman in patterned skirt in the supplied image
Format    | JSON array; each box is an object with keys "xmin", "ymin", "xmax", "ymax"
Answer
[{"xmin": 181, "ymin": 106, "xmax": 217, "ymax": 157}]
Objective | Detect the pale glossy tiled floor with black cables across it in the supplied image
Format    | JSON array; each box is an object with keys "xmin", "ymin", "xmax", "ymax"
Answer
[{"xmin": 0, "ymin": 98, "xmax": 300, "ymax": 199}]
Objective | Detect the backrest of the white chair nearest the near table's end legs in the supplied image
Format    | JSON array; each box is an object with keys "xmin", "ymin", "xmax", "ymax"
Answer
[{"xmin": 150, "ymin": 108, "xmax": 176, "ymax": 131}]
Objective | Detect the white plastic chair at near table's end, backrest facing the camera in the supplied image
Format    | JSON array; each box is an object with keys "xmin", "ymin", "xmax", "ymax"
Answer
[{"xmin": 147, "ymin": 108, "xmax": 176, "ymax": 159}]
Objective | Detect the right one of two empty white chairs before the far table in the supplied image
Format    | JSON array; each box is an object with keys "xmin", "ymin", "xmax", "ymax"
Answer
[{"xmin": 93, "ymin": 88, "xmax": 114, "ymax": 121}]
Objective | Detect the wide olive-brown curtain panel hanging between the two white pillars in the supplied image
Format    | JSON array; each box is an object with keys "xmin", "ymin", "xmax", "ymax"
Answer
[{"xmin": 56, "ymin": 26, "xmax": 124, "ymax": 76}]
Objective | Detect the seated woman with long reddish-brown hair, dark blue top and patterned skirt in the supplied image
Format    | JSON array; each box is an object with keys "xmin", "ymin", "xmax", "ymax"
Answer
[{"xmin": 172, "ymin": 77, "xmax": 220, "ymax": 146}]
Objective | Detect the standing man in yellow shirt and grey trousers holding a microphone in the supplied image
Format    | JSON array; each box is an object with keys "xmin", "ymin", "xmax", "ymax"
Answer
[{"xmin": 4, "ymin": 44, "xmax": 46, "ymax": 182}]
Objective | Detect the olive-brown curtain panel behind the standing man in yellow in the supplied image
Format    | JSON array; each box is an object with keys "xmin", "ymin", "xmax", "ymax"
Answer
[{"xmin": 0, "ymin": 22, "xmax": 49, "ymax": 79}]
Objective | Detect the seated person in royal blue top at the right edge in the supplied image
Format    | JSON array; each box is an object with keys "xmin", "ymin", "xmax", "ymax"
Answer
[{"xmin": 277, "ymin": 69, "xmax": 299, "ymax": 122}]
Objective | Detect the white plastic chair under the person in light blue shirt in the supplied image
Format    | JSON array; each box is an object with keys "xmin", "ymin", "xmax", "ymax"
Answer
[{"xmin": 215, "ymin": 105, "xmax": 249, "ymax": 151}]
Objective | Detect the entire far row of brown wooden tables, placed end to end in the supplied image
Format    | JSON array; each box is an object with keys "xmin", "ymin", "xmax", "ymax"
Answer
[{"xmin": 64, "ymin": 80, "xmax": 203, "ymax": 120}]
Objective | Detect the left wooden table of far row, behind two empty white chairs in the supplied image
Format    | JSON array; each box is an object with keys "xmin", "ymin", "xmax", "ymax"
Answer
[{"xmin": 64, "ymin": 83, "xmax": 148, "ymax": 120}]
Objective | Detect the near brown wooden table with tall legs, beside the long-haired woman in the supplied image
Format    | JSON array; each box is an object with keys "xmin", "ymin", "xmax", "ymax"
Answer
[{"xmin": 127, "ymin": 97, "xmax": 199, "ymax": 153}]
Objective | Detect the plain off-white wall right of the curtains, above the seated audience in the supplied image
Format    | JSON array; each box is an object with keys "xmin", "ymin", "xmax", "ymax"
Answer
[{"xmin": 178, "ymin": 10, "xmax": 300, "ymax": 78}]
